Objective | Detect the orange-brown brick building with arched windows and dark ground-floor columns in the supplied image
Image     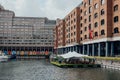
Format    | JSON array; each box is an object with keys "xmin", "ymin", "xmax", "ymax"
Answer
[{"xmin": 55, "ymin": 0, "xmax": 120, "ymax": 56}]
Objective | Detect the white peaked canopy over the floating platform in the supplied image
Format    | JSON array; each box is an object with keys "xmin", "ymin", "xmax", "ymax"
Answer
[{"xmin": 58, "ymin": 51, "xmax": 88, "ymax": 58}]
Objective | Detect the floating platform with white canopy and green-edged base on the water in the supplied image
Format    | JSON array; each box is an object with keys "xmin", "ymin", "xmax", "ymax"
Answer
[{"xmin": 50, "ymin": 52, "xmax": 101, "ymax": 68}]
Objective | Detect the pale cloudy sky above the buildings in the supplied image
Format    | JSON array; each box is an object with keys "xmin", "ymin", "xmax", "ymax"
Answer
[{"xmin": 0, "ymin": 0, "xmax": 82, "ymax": 19}]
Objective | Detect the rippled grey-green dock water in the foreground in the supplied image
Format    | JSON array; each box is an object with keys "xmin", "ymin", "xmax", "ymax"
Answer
[{"xmin": 0, "ymin": 60, "xmax": 120, "ymax": 80}]
